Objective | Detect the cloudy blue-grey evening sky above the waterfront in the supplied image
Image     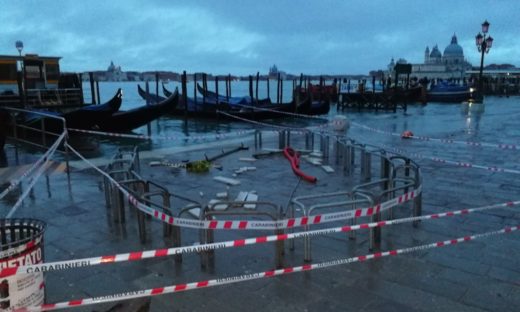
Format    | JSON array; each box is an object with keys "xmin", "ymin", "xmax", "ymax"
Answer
[{"xmin": 0, "ymin": 0, "xmax": 520, "ymax": 75}]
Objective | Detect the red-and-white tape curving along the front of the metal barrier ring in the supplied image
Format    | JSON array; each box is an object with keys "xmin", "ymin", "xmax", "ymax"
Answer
[{"xmin": 67, "ymin": 145, "xmax": 422, "ymax": 230}]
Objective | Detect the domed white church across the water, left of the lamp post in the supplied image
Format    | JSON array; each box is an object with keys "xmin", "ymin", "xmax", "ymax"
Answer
[{"xmin": 388, "ymin": 34, "xmax": 472, "ymax": 79}]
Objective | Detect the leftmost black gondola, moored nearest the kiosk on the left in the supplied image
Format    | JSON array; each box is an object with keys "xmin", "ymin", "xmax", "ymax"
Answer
[{"xmin": 18, "ymin": 89, "xmax": 123, "ymax": 133}]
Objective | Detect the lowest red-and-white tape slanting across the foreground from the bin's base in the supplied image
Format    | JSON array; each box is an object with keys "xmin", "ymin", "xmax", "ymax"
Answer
[{"xmin": 14, "ymin": 226, "xmax": 519, "ymax": 311}]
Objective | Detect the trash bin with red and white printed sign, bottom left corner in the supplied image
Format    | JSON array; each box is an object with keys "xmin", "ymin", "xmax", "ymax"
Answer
[{"xmin": 0, "ymin": 219, "xmax": 45, "ymax": 309}]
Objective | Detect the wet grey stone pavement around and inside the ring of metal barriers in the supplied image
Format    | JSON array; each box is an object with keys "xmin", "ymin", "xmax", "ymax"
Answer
[{"xmin": 0, "ymin": 98, "xmax": 520, "ymax": 311}]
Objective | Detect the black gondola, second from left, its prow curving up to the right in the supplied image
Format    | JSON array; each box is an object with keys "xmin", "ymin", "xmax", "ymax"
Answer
[{"xmin": 97, "ymin": 90, "xmax": 179, "ymax": 132}]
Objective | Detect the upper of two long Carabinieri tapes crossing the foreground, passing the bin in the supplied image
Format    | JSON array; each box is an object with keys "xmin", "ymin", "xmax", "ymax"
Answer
[{"xmin": 0, "ymin": 196, "xmax": 520, "ymax": 278}]
